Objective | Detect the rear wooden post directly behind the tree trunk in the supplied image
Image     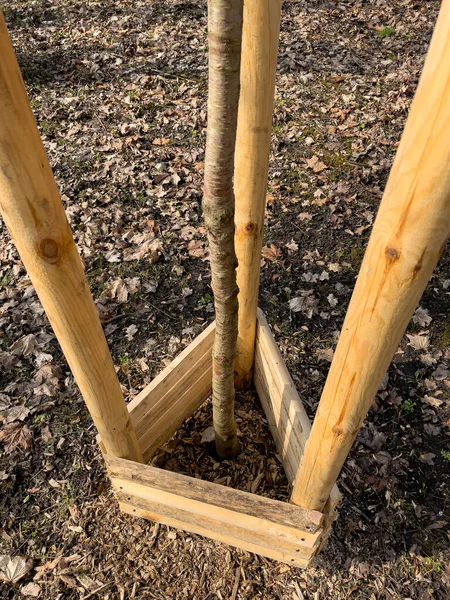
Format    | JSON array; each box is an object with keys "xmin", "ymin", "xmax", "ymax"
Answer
[{"xmin": 234, "ymin": 0, "xmax": 281, "ymax": 389}]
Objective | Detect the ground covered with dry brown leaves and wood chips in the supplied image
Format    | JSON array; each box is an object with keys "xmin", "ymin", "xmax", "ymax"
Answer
[{"xmin": 0, "ymin": 0, "xmax": 450, "ymax": 600}]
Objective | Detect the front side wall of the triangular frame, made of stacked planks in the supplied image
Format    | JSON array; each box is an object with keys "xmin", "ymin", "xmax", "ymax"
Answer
[{"xmin": 105, "ymin": 457, "xmax": 324, "ymax": 566}]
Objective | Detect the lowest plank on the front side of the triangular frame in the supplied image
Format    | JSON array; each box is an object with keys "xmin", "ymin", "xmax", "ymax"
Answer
[{"xmin": 119, "ymin": 501, "xmax": 311, "ymax": 568}]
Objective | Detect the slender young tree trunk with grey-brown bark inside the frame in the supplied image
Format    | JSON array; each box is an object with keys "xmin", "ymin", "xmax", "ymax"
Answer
[{"xmin": 203, "ymin": 0, "xmax": 243, "ymax": 458}]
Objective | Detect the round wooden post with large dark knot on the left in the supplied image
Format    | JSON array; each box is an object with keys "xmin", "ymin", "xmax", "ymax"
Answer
[{"xmin": 0, "ymin": 13, "xmax": 141, "ymax": 461}]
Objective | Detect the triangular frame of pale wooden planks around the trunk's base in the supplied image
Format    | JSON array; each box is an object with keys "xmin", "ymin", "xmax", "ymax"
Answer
[{"xmin": 105, "ymin": 310, "xmax": 339, "ymax": 567}]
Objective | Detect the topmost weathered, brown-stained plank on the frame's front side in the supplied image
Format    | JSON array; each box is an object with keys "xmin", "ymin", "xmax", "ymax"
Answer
[{"xmin": 105, "ymin": 456, "xmax": 323, "ymax": 534}]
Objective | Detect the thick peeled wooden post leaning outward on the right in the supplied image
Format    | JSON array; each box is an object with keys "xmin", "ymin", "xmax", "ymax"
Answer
[{"xmin": 291, "ymin": 0, "xmax": 450, "ymax": 510}]
